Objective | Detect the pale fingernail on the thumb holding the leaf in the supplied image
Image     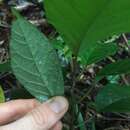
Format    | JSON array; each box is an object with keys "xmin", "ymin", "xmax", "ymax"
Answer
[{"xmin": 49, "ymin": 97, "xmax": 68, "ymax": 113}]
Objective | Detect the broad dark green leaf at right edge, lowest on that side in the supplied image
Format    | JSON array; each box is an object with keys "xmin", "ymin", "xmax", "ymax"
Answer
[{"xmin": 95, "ymin": 84, "xmax": 130, "ymax": 112}]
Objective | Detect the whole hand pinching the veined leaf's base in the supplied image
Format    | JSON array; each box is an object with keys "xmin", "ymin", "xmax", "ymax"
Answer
[{"xmin": 0, "ymin": 97, "xmax": 68, "ymax": 130}]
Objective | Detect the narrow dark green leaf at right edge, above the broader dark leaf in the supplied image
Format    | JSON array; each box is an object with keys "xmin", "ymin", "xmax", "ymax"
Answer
[{"xmin": 97, "ymin": 59, "xmax": 130, "ymax": 77}]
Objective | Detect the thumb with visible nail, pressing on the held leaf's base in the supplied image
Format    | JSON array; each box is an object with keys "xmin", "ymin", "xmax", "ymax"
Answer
[{"xmin": 1, "ymin": 97, "xmax": 68, "ymax": 130}]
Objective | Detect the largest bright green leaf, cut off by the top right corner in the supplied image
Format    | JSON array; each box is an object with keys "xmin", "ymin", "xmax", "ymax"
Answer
[{"xmin": 44, "ymin": 0, "xmax": 130, "ymax": 60}]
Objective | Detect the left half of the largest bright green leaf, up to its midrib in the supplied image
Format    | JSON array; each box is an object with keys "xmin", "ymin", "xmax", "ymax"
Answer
[{"xmin": 44, "ymin": 0, "xmax": 105, "ymax": 53}]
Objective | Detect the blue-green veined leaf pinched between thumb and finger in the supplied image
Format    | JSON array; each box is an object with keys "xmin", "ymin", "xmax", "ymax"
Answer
[{"xmin": 10, "ymin": 18, "xmax": 64, "ymax": 100}]
